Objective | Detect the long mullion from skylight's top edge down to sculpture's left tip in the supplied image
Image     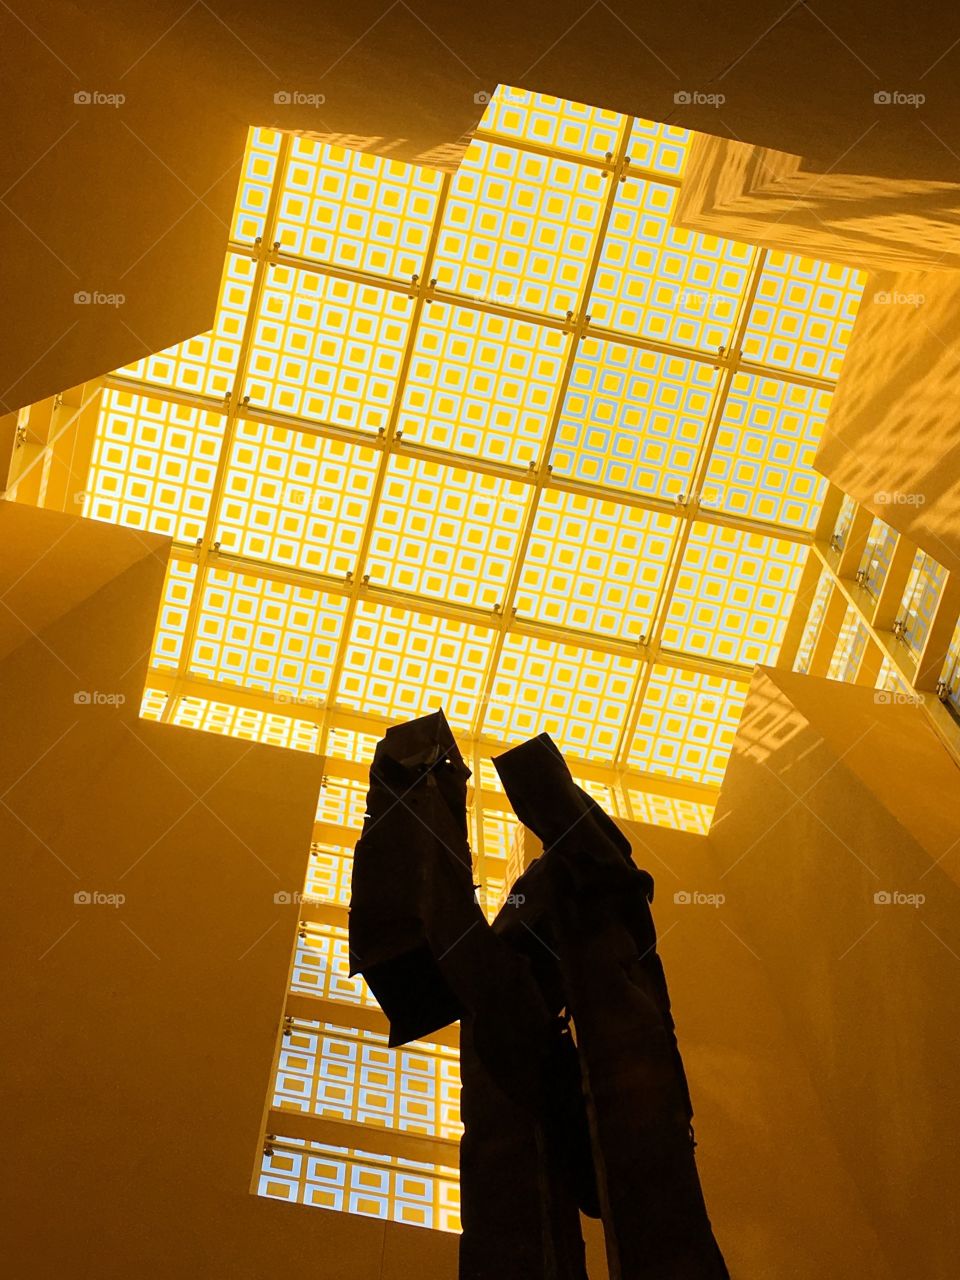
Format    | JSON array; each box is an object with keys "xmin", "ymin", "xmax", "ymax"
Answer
[{"xmin": 471, "ymin": 116, "xmax": 630, "ymax": 739}]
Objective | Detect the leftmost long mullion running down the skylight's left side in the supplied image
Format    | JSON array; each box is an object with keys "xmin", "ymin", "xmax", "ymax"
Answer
[{"xmin": 160, "ymin": 133, "xmax": 293, "ymax": 724}]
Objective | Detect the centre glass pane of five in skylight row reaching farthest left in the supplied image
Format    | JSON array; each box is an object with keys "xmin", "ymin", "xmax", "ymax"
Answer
[{"xmin": 367, "ymin": 456, "xmax": 530, "ymax": 609}]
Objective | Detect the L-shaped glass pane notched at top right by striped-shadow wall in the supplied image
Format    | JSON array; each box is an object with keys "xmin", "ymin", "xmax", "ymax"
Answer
[{"xmin": 590, "ymin": 178, "xmax": 756, "ymax": 351}]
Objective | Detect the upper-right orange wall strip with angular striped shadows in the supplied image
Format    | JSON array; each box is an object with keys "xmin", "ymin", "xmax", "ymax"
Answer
[{"xmin": 675, "ymin": 134, "xmax": 960, "ymax": 271}]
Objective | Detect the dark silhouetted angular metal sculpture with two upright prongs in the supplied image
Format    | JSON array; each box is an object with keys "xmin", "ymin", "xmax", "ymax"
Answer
[{"xmin": 349, "ymin": 712, "xmax": 728, "ymax": 1280}]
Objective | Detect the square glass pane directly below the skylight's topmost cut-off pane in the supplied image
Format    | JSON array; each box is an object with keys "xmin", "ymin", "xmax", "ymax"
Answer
[{"xmin": 434, "ymin": 141, "xmax": 609, "ymax": 317}]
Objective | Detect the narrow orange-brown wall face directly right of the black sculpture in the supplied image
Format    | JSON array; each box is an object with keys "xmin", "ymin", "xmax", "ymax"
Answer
[{"xmin": 586, "ymin": 823, "xmax": 899, "ymax": 1280}]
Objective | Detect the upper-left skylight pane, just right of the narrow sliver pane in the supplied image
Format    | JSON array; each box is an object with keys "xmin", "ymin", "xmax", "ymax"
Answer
[{"xmin": 275, "ymin": 137, "xmax": 443, "ymax": 280}]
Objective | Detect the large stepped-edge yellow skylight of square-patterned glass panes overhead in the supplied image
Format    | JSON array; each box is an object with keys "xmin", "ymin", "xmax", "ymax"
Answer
[{"xmin": 84, "ymin": 88, "xmax": 863, "ymax": 803}]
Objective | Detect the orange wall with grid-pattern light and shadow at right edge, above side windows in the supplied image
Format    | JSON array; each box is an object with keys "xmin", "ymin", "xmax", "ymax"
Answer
[{"xmin": 814, "ymin": 271, "xmax": 960, "ymax": 570}]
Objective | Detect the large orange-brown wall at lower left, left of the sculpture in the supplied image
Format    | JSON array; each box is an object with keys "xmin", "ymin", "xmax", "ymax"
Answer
[{"xmin": 0, "ymin": 508, "xmax": 456, "ymax": 1280}]
